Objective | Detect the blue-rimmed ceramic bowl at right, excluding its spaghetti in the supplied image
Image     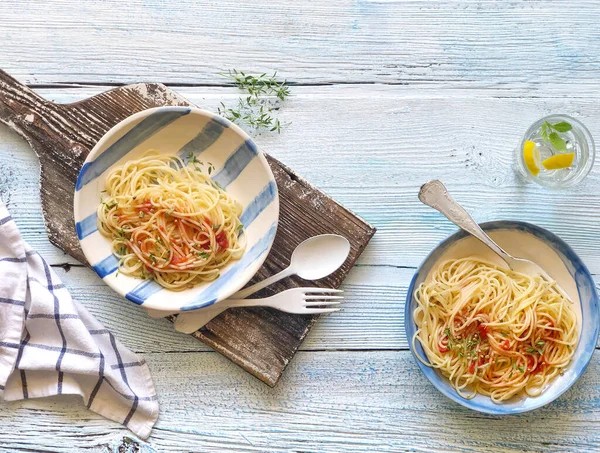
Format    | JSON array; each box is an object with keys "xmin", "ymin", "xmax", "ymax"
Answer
[{"xmin": 404, "ymin": 221, "xmax": 600, "ymax": 415}]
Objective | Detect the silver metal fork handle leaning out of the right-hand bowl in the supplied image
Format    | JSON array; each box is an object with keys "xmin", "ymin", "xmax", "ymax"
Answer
[{"xmin": 419, "ymin": 179, "xmax": 512, "ymax": 264}]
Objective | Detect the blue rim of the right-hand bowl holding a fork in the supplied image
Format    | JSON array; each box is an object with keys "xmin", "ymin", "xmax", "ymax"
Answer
[{"xmin": 404, "ymin": 220, "xmax": 600, "ymax": 415}]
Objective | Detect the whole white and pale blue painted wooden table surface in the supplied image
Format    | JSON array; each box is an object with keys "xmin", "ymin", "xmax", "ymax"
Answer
[{"xmin": 0, "ymin": 0, "xmax": 600, "ymax": 453}]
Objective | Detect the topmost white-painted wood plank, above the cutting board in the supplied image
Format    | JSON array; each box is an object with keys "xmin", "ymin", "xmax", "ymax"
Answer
[{"xmin": 0, "ymin": 0, "xmax": 600, "ymax": 87}]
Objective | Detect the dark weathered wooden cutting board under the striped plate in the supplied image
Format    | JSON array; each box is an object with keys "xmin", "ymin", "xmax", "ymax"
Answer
[{"xmin": 0, "ymin": 70, "xmax": 375, "ymax": 386}]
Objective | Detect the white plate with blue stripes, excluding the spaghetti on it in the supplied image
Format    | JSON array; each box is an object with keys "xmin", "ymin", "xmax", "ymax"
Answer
[{"xmin": 74, "ymin": 107, "xmax": 279, "ymax": 312}]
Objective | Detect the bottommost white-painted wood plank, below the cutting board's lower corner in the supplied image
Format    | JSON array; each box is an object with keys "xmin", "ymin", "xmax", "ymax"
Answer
[{"xmin": 0, "ymin": 351, "xmax": 600, "ymax": 453}]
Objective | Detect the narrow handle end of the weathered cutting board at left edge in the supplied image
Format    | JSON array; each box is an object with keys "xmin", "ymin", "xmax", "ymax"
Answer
[{"xmin": 0, "ymin": 69, "xmax": 47, "ymax": 132}]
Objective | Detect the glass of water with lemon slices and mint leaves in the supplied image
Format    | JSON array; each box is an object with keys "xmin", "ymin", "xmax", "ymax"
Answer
[{"xmin": 516, "ymin": 114, "xmax": 596, "ymax": 189}]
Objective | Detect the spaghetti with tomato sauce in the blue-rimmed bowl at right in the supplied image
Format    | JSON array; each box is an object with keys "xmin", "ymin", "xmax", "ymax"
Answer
[{"xmin": 413, "ymin": 257, "xmax": 579, "ymax": 403}]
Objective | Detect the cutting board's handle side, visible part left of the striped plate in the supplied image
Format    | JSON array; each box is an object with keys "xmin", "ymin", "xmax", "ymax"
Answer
[{"xmin": 0, "ymin": 70, "xmax": 187, "ymax": 263}]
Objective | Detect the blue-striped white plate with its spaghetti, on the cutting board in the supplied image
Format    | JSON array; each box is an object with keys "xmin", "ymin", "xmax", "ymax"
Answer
[{"xmin": 74, "ymin": 107, "xmax": 279, "ymax": 312}]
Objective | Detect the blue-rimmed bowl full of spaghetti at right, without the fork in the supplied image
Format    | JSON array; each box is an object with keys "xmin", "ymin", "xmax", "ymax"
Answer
[{"xmin": 405, "ymin": 221, "xmax": 598, "ymax": 414}]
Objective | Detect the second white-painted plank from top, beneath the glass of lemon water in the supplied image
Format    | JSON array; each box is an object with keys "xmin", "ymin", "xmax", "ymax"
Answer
[{"xmin": 0, "ymin": 85, "xmax": 600, "ymax": 273}]
